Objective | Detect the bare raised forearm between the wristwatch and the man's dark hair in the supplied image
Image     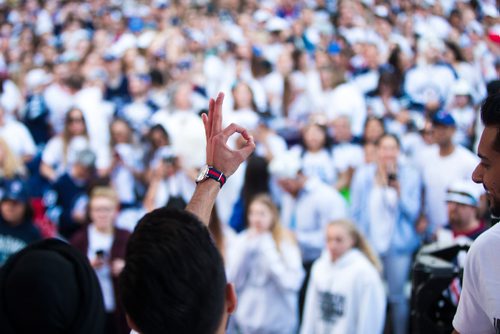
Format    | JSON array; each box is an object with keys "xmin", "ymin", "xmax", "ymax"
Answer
[{"xmin": 186, "ymin": 179, "xmax": 220, "ymax": 227}]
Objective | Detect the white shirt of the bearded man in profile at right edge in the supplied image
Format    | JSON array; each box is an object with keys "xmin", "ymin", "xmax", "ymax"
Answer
[{"xmin": 453, "ymin": 224, "xmax": 500, "ymax": 334}]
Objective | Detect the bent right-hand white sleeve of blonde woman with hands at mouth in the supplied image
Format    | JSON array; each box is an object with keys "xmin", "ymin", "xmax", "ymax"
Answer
[{"xmin": 261, "ymin": 234, "xmax": 304, "ymax": 291}]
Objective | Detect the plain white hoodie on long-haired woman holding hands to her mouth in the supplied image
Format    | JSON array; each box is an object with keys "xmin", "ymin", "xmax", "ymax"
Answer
[{"xmin": 227, "ymin": 231, "xmax": 304, "ymax": 334}]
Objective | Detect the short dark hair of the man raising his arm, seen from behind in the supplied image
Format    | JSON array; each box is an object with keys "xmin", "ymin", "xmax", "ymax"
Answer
[{"xmin": 120, "ymin": 208, "xmax": 226, "ymax": 334}]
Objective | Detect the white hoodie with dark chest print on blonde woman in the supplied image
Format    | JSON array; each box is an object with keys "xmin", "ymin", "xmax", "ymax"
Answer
[{"xmin": 300, "ymin": 248, "xmax": 386, "ymax": 334}]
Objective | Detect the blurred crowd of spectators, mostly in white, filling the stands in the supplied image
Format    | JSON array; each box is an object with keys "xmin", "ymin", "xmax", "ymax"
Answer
[{"xmin": 0, "ymin": 0, "xmax": 500, "ymax": 334}]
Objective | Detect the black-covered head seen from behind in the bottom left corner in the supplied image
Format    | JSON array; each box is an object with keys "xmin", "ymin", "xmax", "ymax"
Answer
[{"xmin": 0, "ymin": 239, "xmax": 105, "ymax": 334}]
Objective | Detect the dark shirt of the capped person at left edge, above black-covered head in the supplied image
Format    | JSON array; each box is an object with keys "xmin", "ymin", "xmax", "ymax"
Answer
[{"xmin": 0, "ymin": 218, "xmax": 42, "ymax": 266}]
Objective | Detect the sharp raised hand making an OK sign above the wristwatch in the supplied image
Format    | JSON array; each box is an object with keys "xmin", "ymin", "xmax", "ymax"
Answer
[{"xmin": 201, "ymin": 93, "xmax": 255, "ymax": 177}]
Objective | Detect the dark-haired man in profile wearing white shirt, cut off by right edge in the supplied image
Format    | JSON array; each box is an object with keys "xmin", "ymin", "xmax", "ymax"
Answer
[{"xmin": 453, "ymin": 93, "xmax": 500, "ymax": 334}]
